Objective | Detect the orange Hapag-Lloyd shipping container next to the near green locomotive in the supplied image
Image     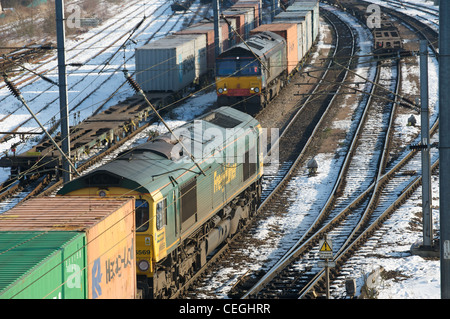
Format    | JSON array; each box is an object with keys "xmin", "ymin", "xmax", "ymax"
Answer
[{"xmin": 0, "ymin": 198, "xmax": 136, "ymax": 299}]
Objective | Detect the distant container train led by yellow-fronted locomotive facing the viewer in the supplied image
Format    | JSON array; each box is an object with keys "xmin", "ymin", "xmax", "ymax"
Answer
[{"xmin": 216, "ymin": 0, "xmax": 319, "ymax": 113}]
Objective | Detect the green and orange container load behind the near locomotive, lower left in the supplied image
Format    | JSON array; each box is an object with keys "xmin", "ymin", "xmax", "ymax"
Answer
[{"xmin": 0, "ymin": 197, "xmax": 136, "ymax": 299}]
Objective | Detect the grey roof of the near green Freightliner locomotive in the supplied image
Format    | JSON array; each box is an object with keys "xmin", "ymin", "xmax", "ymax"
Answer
[{"xmin": 58, "ymin": 107, "xmax": 258, "ymax": 195}]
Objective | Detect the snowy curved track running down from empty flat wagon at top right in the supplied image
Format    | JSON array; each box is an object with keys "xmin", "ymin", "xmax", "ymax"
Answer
[{"xmin": 239, "ymin": 43, "xmax": 398, "ymax": 298}]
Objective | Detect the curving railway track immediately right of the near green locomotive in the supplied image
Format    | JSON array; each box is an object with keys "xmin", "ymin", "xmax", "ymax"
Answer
[{"xmin": 173, "ymin": 5, "xmax": 362, "ymax": 298}]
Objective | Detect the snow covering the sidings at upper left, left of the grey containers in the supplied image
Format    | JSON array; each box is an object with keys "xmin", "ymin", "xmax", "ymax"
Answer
[{"xmin": 0, "ymin": 0, "xmax": 206, "ymax": 185}]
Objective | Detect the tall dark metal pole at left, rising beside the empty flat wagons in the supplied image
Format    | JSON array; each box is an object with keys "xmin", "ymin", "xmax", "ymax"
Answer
[{"xmin": 55, "ymin": 0, "xmax": 71, "ymax": 183}]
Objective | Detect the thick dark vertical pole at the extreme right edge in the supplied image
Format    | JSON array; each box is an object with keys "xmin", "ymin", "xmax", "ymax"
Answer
[{"xmin": 439, "ymin": 0, "xmax": 450, "ymax": 299}]
